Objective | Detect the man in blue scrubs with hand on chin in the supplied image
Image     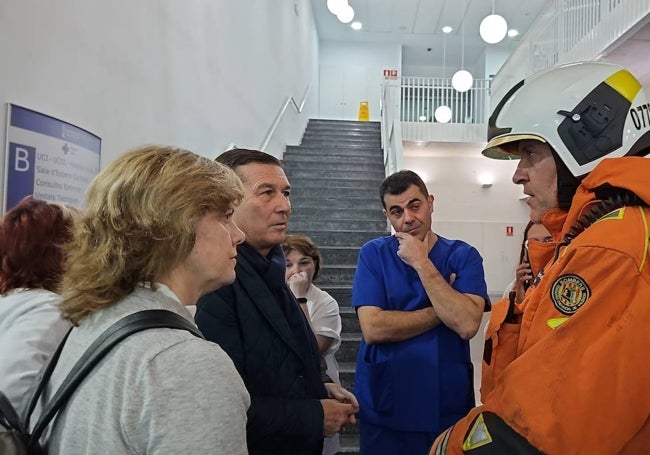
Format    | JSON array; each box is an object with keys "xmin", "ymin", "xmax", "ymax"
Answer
[{"xmin": 352, "ymin": 171, "xmax": 489, "ymax": 455}]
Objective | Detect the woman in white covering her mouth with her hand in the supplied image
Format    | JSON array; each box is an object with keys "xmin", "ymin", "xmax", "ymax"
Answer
[{"xmin": 282, "ymin": 235, "xmax": 341, "ymax": 455}]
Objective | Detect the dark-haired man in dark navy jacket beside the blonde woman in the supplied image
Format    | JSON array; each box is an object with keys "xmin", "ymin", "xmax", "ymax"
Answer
[{"xmin": 196, "ymin": 149, "xmax": 358, "ymax": 455}]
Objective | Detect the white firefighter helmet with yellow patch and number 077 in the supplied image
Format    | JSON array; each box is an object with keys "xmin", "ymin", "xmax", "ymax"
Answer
[{"xmin": 483, "ymin": 62, "xmax": 650, "ymax": 177}]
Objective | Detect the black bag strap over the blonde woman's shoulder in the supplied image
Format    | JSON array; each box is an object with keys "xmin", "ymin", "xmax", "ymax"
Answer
[{"xmin": 29, "ymin": 310, "xmax": 203, "ymax": 446}]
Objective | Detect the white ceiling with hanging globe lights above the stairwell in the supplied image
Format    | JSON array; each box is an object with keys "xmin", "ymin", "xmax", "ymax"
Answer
[{"xmin": 311, "ymin": 0, "xmax": 546, "ymax": 73}]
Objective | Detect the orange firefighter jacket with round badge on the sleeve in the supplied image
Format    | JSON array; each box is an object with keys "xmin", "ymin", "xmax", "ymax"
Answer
[{"xmin": 430, "ymin": 157, "xmax": 650, "ymax": 455}]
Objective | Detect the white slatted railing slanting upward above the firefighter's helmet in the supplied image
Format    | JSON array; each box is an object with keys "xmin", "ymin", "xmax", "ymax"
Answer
[{"xmin": 491, "ymin": 0, "xmax": 650, "ymax": 107}]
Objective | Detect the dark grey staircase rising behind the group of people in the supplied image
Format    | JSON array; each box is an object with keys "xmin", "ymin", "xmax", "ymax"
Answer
[{"xmin": 284, "ymin": 120, "xmax": 388, "ymax": 454}]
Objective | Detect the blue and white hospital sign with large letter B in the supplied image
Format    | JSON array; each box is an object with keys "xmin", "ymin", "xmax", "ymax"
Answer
[{"xmin": 4, "ymin": 104, "xmax": 101, "ymax": 211}]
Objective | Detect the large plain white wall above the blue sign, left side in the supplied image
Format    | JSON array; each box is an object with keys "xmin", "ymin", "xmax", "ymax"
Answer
[{"xmin": 0, "ymin": 0, "xmax": 318, "ymax": 202}]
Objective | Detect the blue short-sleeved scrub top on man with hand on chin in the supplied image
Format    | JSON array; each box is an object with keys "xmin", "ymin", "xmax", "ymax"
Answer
[{"xmin": 352, "ymin": 236, "xmax": 489, "ymax": 432}]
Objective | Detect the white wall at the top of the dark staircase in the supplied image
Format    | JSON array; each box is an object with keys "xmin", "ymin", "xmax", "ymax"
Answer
[{"xmin": 318, "ymin": 41, "xmax": 402, "ymax": 121}]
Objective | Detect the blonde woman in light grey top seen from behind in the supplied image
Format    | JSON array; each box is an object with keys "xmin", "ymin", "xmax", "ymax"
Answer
[{"xmin": 46, "ymin": 146, "xmax": 250, "ymax": 455}]
